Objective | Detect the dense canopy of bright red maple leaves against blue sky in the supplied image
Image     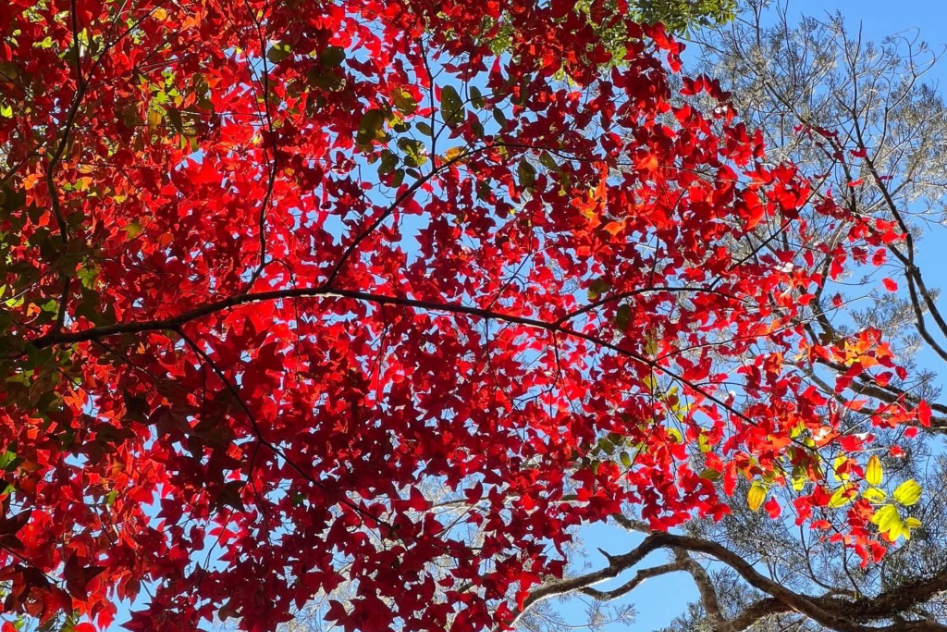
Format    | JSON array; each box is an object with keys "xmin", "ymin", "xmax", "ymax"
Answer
[{"xmin": 0, "ymin": 0, "xmax": 924, "ymax": 632}]
